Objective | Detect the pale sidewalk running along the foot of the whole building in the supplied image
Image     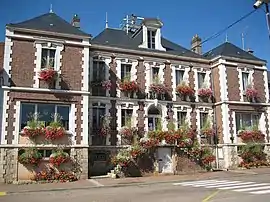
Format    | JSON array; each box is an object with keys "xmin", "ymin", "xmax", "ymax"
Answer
[{"xmin": 0, "ymin": 168, "xmax": 262, "ymax": 193}]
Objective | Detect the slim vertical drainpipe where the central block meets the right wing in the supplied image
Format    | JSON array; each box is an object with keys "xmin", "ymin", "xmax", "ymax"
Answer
[{"xmin": 210, "ymin": 67, "xmax": 219, "ymax": 170}]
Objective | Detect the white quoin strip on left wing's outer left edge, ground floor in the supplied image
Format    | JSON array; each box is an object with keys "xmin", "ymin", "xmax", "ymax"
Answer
[{"xmin": 1, "ymin": 91, "xmax": 10, "ymax": 144}]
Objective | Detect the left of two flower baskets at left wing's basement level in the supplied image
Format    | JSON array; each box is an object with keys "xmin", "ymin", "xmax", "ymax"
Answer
[{"xmin": 18, "ymin": 148, "xmax": 42, "ymax": 166}]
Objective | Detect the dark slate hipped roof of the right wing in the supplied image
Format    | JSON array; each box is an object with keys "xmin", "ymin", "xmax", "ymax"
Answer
[{"xmin": 204, "ymin": 42, "xmax": 266, "ymax": 62}]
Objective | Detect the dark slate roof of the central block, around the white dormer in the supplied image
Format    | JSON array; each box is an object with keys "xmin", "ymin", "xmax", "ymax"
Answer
[{"xmin": 91, "ymin": 28, "xmax": 205, "ymax": 59}]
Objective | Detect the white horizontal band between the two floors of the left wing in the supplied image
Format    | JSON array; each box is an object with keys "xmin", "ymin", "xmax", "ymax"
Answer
[{"xmin": 2, "ymin": 86, "xmax": 90, "ymax": 95}]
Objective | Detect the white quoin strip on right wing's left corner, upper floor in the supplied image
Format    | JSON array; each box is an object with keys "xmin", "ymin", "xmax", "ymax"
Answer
[{"xmin": 218, "ymin": 64, "xmax": 229, "ymax": 101}]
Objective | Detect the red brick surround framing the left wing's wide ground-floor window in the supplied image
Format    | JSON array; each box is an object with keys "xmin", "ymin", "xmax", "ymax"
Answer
[{"xmin": 5, "ymin": 92, "xmax": 83, "ymax": 144}]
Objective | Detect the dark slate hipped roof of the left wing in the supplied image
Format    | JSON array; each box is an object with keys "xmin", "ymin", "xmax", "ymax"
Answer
[{"xmin": 7, "ymin": 13, "xmax": 90, "ymax": 37}]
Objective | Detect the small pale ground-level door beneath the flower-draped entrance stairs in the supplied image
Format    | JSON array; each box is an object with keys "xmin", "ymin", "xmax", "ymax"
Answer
[{"xmin": 158, "ymin": 147, "xmax": 173, "ymax": 173}]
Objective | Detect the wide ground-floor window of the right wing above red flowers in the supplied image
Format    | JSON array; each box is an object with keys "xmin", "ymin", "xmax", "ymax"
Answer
[{"xmin": 235, "ymin": 113, "xmax": 260, "ymax": 132}]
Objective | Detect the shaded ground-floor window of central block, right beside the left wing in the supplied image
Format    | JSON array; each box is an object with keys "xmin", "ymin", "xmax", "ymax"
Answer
[{"xmin": 92, "ymin": 103, "xmax": 106, "ymax": 131}]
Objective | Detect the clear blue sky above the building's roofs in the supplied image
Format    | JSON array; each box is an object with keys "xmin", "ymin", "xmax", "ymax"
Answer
[{"xmin": 0, "ymin": 0, "xmax": 270, "ymax": 64}]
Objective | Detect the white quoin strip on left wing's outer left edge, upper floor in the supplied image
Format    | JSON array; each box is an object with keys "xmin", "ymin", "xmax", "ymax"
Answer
[{"xmin": 3, "ymin": 29, "xmax": 13, "ymax": 86}]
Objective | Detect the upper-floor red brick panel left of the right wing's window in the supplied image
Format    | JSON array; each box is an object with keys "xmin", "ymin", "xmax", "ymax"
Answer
[{"xmin": 226, "ymin": 66, "xmax": 240, "ymax": 101}]
